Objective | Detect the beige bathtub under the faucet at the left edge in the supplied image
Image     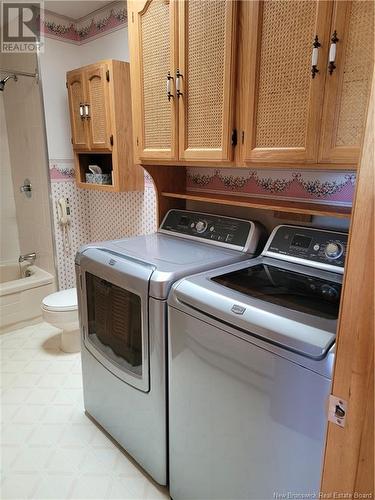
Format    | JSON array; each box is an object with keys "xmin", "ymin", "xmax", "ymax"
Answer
[{"xmin": 0, "ymin": 262, "xmax": 56, "ymax": 333}]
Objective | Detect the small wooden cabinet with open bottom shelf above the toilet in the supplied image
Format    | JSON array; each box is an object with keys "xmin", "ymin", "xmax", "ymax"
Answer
[{"xmin": 66, "ymin": 60, "xmax": 144, "ymax": 191}]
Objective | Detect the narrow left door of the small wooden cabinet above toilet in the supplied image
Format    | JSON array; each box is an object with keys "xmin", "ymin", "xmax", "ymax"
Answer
[{"xmin": 66, "ymin": 70, "xmax": 89, "ymax": 150}]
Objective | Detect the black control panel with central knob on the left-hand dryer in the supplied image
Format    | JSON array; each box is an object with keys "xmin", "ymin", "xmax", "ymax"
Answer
[{"xmin": 159, "ymin": 209, "xmax": 254, "ymax": 251}]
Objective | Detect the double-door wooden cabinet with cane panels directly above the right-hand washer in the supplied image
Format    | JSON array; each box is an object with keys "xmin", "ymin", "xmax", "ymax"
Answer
[{"xmin": 239, "ymin": 0, "xmax": 374, "ymax": 168}]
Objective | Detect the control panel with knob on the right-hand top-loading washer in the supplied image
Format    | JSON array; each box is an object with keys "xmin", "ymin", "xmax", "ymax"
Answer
[{"xmin": 263, "ymin": 226, "xmax": 348, "ymax": 268}]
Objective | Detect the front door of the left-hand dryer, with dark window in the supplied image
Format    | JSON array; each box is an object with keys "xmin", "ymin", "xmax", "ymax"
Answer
[{"xmin": 78, "ymin": 249, "xmax": 153, "ymax": 392}]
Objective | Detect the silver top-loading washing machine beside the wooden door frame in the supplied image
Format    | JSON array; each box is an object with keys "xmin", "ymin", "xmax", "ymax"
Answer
[{"xmin": 168, "ymin": 225, "xmax": 347, "ymax": 500}]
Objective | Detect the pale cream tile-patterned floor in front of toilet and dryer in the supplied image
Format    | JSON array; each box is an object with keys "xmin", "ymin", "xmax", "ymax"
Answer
[{"xmin": 0, "ymin": 323, "xmax": 169, "ymax": 500}]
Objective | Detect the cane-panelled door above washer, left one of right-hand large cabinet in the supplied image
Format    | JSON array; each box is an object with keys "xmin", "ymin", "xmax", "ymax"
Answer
[{"xmin": 240, "ymin": 0, "xmax": 332, "ymax": 163}]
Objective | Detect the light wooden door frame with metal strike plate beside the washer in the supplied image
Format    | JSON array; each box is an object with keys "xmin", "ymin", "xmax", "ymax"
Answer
[{"xmin": 321, "ymin": 73, "xmax": 375, "ymax": 498}]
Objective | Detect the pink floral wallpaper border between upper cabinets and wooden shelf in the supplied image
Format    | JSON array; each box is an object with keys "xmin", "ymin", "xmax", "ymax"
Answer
[{"xmin": 187, "ymin": 168, "xmax": 356, "ymax": 206}]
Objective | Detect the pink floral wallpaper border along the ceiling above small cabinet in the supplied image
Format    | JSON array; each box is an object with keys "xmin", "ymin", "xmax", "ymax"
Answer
[{"xmin": 42, "ymin": 1, "xmax": 128, "ymax": 45}]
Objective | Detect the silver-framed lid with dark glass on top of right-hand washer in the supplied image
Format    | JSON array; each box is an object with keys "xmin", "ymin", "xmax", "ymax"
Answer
[{"xmin": 168, "ymin": 257, "xmax": 342, "ymax": 360}]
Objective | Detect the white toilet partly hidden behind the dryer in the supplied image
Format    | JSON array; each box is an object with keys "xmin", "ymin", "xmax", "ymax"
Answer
[{"xmin": 42, "ymin": 288, "xmax": 81, "ymax": 352}]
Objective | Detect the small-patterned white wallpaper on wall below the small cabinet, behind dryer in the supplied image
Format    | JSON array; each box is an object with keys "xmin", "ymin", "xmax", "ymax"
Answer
[{"xmin": 50, "ymin": 160, "xmax": 156, "ymax": 289}]
